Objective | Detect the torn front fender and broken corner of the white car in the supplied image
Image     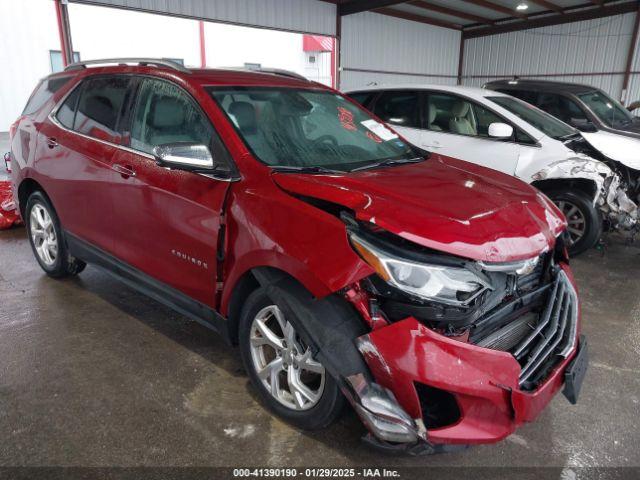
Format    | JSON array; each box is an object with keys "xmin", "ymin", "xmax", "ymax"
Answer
[{"xmin": 532, "ymin": 155, "xmax": 640, "ymax": 237}]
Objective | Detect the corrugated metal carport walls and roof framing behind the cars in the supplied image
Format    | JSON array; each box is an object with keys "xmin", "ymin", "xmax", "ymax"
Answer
[{"xmin": 55, "ymin": 0, "xmax": 640, "ymax": 100}]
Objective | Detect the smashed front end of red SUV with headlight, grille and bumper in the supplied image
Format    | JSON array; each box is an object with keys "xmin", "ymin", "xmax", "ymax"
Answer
[{"xmin": 345, "ymin": 222, "xmax": 579, "ymax": 454}]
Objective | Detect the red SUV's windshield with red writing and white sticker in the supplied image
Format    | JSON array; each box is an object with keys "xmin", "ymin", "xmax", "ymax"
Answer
[{"xmin": 209, "ymin": 87, "xmax": 419, "ymax": 171}]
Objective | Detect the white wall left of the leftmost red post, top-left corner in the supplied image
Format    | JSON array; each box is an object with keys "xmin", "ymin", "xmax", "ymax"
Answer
[{"xmin": 0, "ymin": 0, "xmax": 60, "ymax": 132}]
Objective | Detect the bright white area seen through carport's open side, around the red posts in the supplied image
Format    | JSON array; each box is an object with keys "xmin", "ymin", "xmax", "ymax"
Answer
[{"xmin": 0, "ymin": 0, "xmax": 331, "ymax": 132}]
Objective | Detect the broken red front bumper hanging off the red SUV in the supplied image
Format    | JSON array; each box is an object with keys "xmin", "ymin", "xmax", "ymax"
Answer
[{"xmin": 357, "ymin": 264, "xmax": 584, "ymax": 453}]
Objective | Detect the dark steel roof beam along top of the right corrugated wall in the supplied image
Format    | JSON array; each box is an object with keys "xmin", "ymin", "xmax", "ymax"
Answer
[{"xmin": 463, "ymin": 0, "xmax": 638, "ymax": 39}]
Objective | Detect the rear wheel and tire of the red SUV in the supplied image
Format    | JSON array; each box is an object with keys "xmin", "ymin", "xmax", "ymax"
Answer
[{"xmin": 24, "ymin": 191, "xmax": 87, "ymax": 278}]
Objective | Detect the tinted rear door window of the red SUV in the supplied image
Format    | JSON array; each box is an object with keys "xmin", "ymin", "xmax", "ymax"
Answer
[{"xmin": 73, "ymin": 76, "xmax": 131, "ymax": 143}]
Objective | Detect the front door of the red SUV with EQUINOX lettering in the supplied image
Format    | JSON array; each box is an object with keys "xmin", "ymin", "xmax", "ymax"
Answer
[{"xmin": 111, "ymin": 78, "xmax": 231, "ymax": 306}]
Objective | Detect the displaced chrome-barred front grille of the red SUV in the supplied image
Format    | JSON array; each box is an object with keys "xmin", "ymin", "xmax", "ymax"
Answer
[{"xmin": 511, "ymin": 270, "xmax": 578, "ymax": 390}]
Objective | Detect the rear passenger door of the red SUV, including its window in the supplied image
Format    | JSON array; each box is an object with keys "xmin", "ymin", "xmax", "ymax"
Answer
[{"xmin": 38, "ymin": 75, "xmax": 131, "ymax": 253}]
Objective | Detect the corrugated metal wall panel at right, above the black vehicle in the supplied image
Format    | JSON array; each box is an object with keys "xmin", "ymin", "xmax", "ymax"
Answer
[{"xmin": 464, "ymin": 13, "xmax": 640, "ymax": 105}]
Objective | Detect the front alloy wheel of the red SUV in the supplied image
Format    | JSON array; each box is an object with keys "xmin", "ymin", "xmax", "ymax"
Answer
[{"xmin": 249, "ymin": 305, "xmax": 326, "ymax": 411}]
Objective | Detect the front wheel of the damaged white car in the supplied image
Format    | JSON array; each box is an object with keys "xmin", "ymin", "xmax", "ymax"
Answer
[{"xmin": 546, "ymin": 190, "xmax": 603, "ymax": 257}]
